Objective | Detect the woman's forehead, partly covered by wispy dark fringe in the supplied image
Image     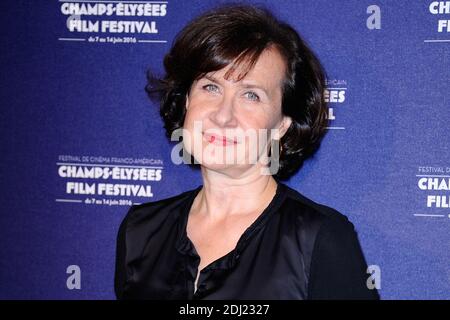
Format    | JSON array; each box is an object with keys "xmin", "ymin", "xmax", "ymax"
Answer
[{"xmin": 208, "ymin": 48, "xmax": 286, "ymax": 90}]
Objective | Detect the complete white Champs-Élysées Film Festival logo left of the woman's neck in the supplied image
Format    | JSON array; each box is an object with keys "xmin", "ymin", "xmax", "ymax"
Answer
[{"xmin": 56, "ymin": 155, "xmax": 163, "ymax": 206}]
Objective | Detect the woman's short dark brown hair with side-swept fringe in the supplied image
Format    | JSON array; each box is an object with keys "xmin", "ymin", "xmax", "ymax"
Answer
[{"xmin": 145, "ymin": 3, "xmax": 328, "ymax": 180}]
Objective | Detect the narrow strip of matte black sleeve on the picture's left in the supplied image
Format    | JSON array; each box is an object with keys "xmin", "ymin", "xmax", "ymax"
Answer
[{"xmin": 114, "ymin": 205, "xmax": 134, "ymax": 299}]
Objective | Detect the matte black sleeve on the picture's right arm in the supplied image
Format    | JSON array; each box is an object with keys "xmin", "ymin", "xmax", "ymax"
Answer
[{"xmin": 308, "ymin": 219, "xmax": 380, "ymax": 300}]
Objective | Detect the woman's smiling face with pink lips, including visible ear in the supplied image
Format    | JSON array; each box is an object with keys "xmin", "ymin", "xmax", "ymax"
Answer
[{"xmin": 183, "ymin": 48, "xmax": 291, "ymax": 175}]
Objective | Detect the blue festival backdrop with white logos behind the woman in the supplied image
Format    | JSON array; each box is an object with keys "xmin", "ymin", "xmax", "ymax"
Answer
[{"xmin": 0, "ymin": 0, "xmax": 450, "ymax": 299}]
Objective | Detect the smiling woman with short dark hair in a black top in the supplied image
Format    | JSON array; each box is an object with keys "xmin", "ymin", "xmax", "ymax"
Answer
[{"xmin": 115, "ymin": 5, "xmax": 378, "ymax": 299}]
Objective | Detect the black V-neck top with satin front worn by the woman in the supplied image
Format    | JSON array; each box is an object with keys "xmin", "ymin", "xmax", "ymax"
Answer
[{"xmin": 115, "ymin": 182, "xmax": 379, "ymax": 300}]
